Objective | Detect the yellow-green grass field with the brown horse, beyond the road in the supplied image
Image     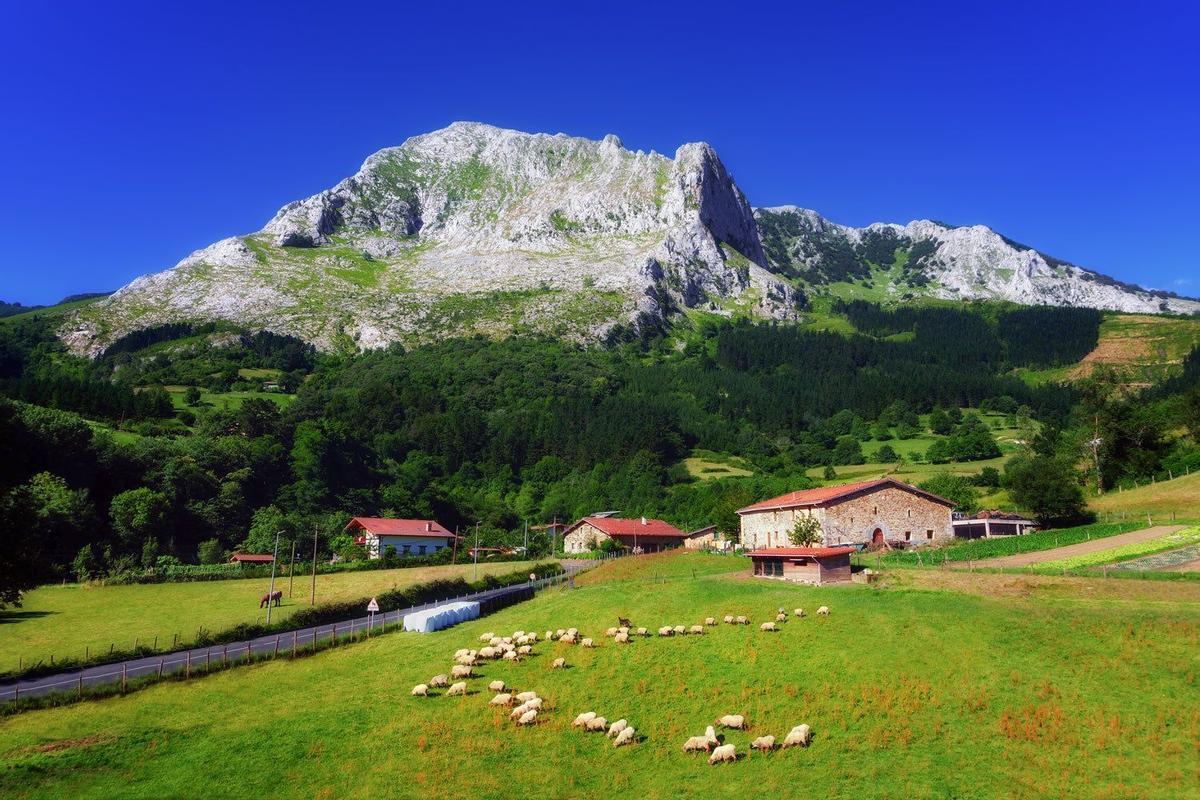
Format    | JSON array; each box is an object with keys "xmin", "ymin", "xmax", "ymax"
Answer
[{"xmin": 0, "ymin": 561, "xmax": 544, "ymax": 670}]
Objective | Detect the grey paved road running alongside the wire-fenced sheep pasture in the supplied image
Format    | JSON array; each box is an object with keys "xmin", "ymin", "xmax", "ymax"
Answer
[{"xmin": 0, "ymin": 560, "xmax": 598, "ymax": 703}]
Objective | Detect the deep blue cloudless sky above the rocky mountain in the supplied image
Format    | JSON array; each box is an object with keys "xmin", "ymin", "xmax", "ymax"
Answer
[{"xmin": 0, "ymin": 0, "xmax": 1200, "ymax": 303}]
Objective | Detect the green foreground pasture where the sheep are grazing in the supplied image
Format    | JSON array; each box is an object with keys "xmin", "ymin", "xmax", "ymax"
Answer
[{"xmin": 0, "ymin": 554, "xmax": 1200, "ymax": 800}]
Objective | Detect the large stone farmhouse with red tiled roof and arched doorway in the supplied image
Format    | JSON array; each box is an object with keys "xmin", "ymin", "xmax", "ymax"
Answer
[{"xmin": 737, "ymin": 477, "xmax": 954, "ymax": 551}]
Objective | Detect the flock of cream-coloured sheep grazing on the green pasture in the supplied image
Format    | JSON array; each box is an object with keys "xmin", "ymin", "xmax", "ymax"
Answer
[{"xmin": 412, "ymin": 606, "xmax": 829, "ymax": 764}]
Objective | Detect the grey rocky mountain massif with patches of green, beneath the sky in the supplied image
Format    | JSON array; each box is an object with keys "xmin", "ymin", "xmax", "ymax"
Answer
[{"xmin": 60, "ymin": 122, "xmax": 1200, "ymax": 355}]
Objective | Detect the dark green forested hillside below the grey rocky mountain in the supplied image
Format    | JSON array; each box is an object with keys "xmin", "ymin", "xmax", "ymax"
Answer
[{"xmin": 0, "ymin": 303, "xmax": 1200, "ymax": 600}]
